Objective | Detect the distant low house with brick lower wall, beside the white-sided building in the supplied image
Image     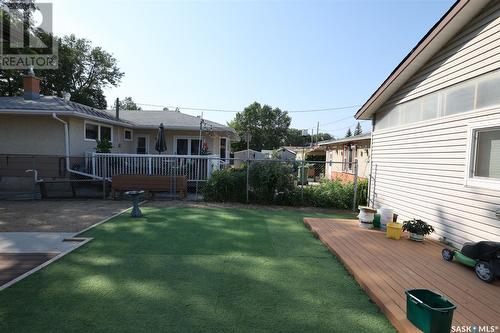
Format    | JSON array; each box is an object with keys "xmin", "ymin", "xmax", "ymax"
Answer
[{"xmin": 318, "ymin": 133, "xmax": 371, "ymax": 181}]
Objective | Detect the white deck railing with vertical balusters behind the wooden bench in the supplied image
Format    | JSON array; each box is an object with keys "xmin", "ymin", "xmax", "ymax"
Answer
[{"xmin": 86, "ymin": 152, "xmax": 222, "ymax": 181}]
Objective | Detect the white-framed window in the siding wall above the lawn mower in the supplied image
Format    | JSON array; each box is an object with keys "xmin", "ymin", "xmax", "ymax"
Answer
[{"xmin": 466, "ymin": 122, "xmax": 500, "ymax": 189}]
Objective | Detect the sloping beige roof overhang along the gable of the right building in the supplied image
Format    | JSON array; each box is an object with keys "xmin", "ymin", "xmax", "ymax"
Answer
[{"xmin": 355, "ymin": 0, "xmax": 490, "ymax": 119}]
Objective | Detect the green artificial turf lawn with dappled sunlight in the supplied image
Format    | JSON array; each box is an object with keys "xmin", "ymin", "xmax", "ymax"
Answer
[{"xmin": 0, "ymin": 207, "xmax": 394, "ymax": 333}]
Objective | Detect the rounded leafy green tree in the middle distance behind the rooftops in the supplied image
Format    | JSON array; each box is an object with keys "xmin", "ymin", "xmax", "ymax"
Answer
[{"xmin": 229, "ymin": 102, "xmax": 292, "ymax": 150}]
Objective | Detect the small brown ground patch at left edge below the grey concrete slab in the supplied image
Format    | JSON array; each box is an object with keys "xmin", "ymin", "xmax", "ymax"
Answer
[{"xmin": 0, "ymin": 253, "xmax": 57, "ymax": 286}]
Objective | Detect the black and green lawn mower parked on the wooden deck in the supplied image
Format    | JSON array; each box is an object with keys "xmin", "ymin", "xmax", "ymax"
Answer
[{"xmin": 441, "ymin": 241, "xmax": 500, "ymax": 283}]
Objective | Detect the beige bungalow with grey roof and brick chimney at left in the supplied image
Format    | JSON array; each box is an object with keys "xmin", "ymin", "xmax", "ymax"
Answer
[{"xmin": 0, "ymin": 71, "xmax": 237, "ymax": 186}]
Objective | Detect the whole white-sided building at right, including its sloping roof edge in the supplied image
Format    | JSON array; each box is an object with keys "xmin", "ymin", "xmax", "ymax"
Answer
[{"xmin": 356, "ymin": 0, "xmax": 500, "ymax": 244}]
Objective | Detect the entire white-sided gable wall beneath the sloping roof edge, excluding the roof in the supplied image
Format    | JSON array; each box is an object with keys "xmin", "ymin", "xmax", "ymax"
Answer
[{"xmin": 370, "ymin": 1, "xmax": 500, "ymax": 245}]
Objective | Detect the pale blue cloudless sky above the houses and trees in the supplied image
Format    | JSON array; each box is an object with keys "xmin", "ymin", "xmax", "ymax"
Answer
[{"xmin": 49, "ymin": 0, "xmax": 453, "ymax": 136}]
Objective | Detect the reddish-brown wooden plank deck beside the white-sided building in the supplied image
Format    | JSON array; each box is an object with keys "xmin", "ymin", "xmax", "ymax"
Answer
[{"xmin": 304, "ymin": 218, "xmax": 500, "ymax": 332}]
